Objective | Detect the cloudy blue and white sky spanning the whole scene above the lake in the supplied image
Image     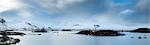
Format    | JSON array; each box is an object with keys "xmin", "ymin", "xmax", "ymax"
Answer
[{"xmin": 0, "ymin": 0, "xmax": 150, "ymax": 29}]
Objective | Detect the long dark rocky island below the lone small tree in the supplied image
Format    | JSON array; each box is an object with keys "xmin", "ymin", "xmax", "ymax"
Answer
[{"xmin": 77, "ymin": 30, "xmax": 125, "ymax": 36}]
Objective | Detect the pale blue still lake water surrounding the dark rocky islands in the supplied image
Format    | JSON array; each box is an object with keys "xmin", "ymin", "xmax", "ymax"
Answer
[{"xmin": 8, "ymin": 31, "xmax": 150, "ymax": 45}]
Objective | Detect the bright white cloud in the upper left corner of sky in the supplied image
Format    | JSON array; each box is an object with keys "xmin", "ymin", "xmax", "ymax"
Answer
[{"xmin": 0, "ymin": 0, "xmax": 33, "ymax": 17}]
